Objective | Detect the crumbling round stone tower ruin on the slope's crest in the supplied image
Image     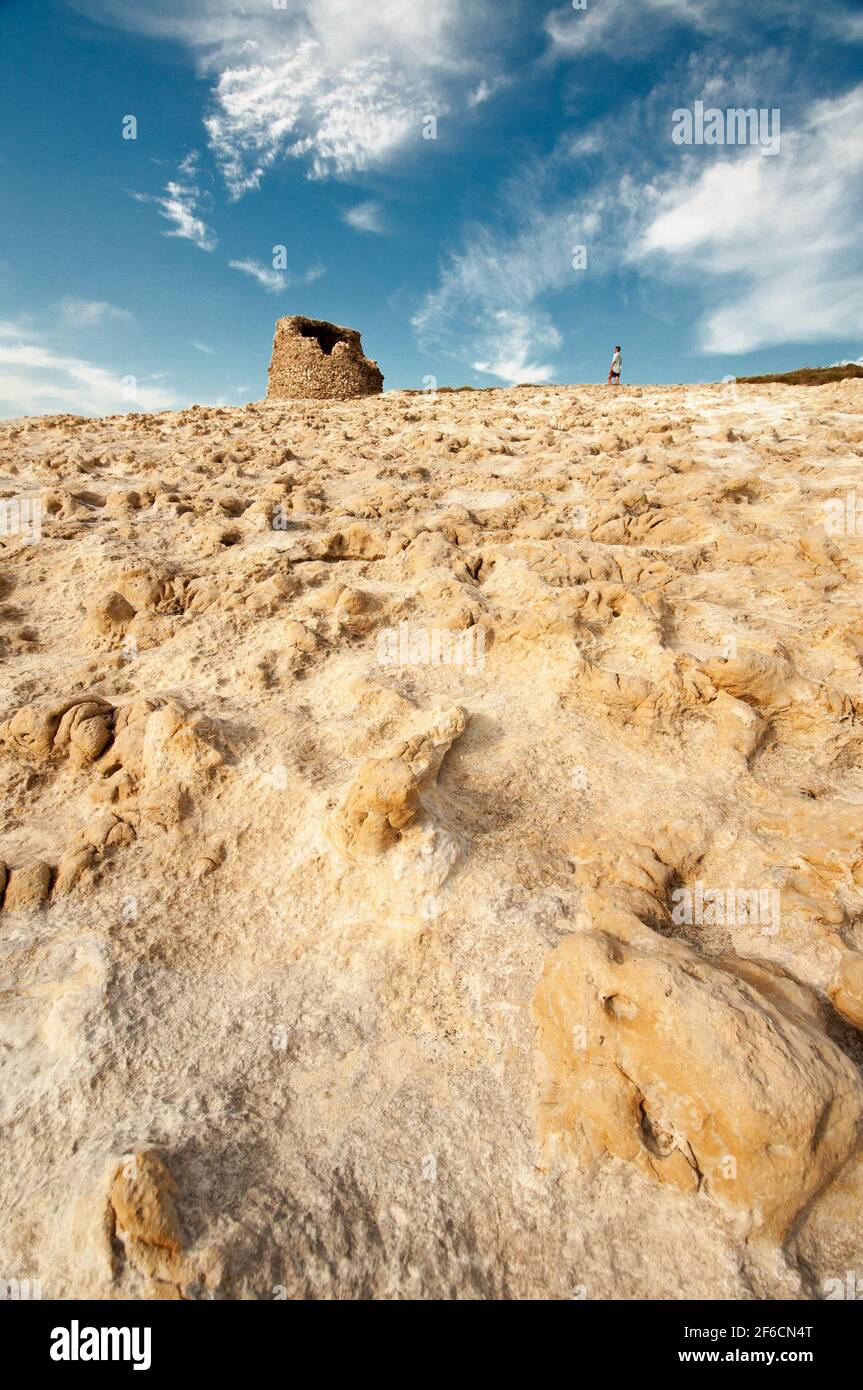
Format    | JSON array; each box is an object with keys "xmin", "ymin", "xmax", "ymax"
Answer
[{"xmin": 267, "ymin": 314, "xmax": 384, "ymax": 400}]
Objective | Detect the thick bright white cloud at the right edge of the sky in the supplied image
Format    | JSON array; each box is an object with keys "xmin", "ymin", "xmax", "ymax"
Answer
[{"xmin": 630, "ymin": 85, "xmax": 863, "ymax": 353}]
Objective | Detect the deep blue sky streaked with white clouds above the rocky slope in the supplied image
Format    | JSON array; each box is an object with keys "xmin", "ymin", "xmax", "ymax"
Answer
[{"xmin": 0, "ymin": 0, "xmax": 863, "ymax": 416}]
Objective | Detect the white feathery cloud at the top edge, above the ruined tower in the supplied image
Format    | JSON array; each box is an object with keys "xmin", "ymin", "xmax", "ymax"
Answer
[{"xmin": 78, "ymin": 0, "xmax": 498, "ymax": 197}]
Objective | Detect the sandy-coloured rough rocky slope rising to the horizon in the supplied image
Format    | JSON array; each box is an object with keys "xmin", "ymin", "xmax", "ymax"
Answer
[{"xmin": 0, "ymin": 382, "xmax": 863, "ymax": 1300}]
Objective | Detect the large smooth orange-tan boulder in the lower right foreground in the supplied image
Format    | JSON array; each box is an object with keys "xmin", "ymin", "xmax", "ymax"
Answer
[{"xmin": 534, "ymin": 929, "xmax": 863, "ymax": 1237}]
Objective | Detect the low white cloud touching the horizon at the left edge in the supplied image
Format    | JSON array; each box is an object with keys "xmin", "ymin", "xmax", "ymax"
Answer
[{"xmin": 0, "ymin": 324, "xmax": 176, "ymax": 418}]
